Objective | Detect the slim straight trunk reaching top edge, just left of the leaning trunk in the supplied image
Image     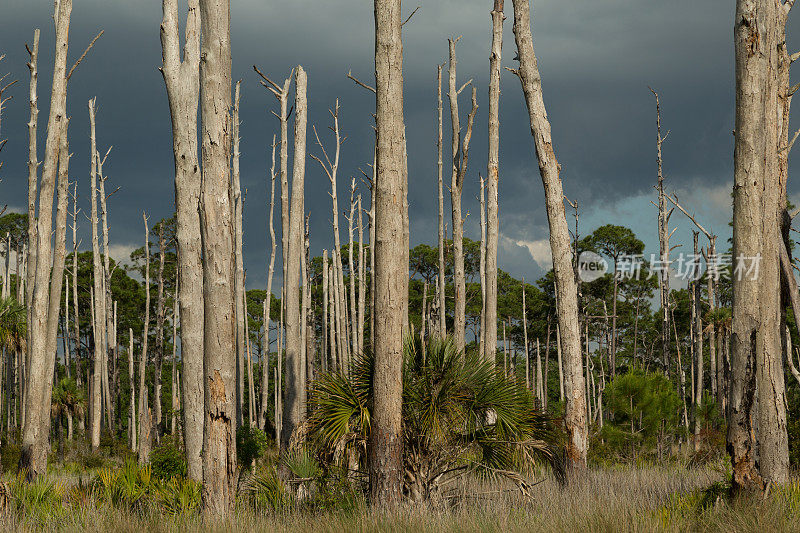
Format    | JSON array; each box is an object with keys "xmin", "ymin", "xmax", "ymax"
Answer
[{"xmin": 482, "ymin": 0, "xmax": 505, "ymax": 362}]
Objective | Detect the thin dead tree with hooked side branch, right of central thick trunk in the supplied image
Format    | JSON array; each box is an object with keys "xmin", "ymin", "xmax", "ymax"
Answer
[{"xmin": 448, "ymin": 37, "xmax": 478, "ymax": 352}]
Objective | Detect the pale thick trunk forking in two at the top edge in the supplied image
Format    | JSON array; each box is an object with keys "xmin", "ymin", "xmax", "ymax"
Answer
[{"xmin": 161, "ymin": 0, "xmax": 204, "ymax": 481}]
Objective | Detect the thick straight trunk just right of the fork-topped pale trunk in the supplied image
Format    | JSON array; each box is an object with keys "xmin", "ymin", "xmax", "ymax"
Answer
[{"xmin": 200, "ymin": 0, "xmax": 237, "ymax": 516}]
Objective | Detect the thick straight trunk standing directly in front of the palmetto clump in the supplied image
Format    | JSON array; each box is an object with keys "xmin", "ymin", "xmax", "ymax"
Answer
[{"xmin": 369, "ymin": 0, "xmax": 406, "ymax": 506}]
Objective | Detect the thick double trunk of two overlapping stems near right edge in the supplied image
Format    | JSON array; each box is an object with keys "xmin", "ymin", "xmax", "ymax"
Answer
[{"xmin": 727, "ymin": 0, "xmax": 785, "ymax": 490}]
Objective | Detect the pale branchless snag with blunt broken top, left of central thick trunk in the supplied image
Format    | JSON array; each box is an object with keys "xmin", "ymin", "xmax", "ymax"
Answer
[{"xmin": 281, "ymin": 66, "xmax": 308, "ymax": 451}]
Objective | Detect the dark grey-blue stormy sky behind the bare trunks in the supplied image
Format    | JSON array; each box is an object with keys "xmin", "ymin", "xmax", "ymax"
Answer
[{"xmin": 0, "ymin": 0, "xmax": 800, "ymax": 288}]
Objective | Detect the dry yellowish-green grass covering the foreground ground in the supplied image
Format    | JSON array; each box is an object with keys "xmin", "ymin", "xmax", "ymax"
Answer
[{"xmin": 0, "ymin": 465, "xmax": 800, "ymax": 533}]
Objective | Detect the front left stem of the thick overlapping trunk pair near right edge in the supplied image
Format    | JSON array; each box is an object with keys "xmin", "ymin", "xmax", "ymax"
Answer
[{"xmin": 727, "ymin": 0, "xmax": 777, "ymax": 490}]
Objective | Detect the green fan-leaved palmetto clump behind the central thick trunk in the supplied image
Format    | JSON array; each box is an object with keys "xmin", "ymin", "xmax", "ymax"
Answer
[{"xmin": 305, "ymin": 337, "xmax": 563, "ymax": 498}]
